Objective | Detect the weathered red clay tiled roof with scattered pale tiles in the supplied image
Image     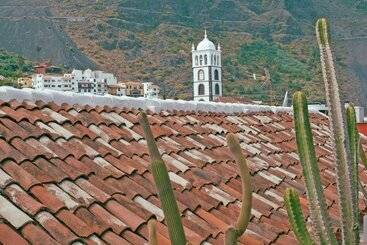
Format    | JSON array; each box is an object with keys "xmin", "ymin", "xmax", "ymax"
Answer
[{"xmin": 0, "ymin": 89, "xmax": 367, "ymax": 244}]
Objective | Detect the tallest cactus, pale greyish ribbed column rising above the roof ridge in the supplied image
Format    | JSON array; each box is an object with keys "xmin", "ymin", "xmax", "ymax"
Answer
[{"xmin": 316, "ymin": 18, "xmax": 359, "ymax": 244}]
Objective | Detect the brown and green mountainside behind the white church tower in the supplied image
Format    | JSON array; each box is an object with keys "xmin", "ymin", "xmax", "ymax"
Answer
[{"xmin": 0, "ymin": 0, "xmax": 367, "ymax": 104}]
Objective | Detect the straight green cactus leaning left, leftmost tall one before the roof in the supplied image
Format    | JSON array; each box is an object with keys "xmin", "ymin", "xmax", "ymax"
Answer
[{"xmin": 139, "ymin": 112, "xmax": 186, "ymax": 245}]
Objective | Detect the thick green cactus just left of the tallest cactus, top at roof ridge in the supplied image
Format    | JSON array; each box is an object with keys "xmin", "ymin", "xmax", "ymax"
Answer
[{"xmin": 293, "ymin": 92, "xmax": 337, "ymax": 244}]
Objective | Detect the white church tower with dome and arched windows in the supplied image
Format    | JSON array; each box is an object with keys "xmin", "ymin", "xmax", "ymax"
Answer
[{"xmin": 191, "ymin": 30, "xmax": 222, "ymax": 101}]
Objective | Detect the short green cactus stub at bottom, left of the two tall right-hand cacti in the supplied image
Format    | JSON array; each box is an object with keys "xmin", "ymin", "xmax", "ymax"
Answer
[{"xmin": 284, "ymin": 188, "xmax": 315, "ymax": 245}]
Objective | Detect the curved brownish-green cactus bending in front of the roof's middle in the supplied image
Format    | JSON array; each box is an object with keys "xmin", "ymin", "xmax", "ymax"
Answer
[{"xmin": 225, "ymin": 134, "xmax": 252, "ymax": 245}]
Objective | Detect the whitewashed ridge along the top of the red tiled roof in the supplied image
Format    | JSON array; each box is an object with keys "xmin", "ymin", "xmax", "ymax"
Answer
[{"xmin": 0, "ymin": 86, "xmax": 298, "ymax": 114}]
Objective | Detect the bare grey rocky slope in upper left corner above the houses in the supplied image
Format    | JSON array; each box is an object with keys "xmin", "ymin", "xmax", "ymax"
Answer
[{"xmin": 0, "ymin": 0, "xmax": 95, "ymax": 68}]
